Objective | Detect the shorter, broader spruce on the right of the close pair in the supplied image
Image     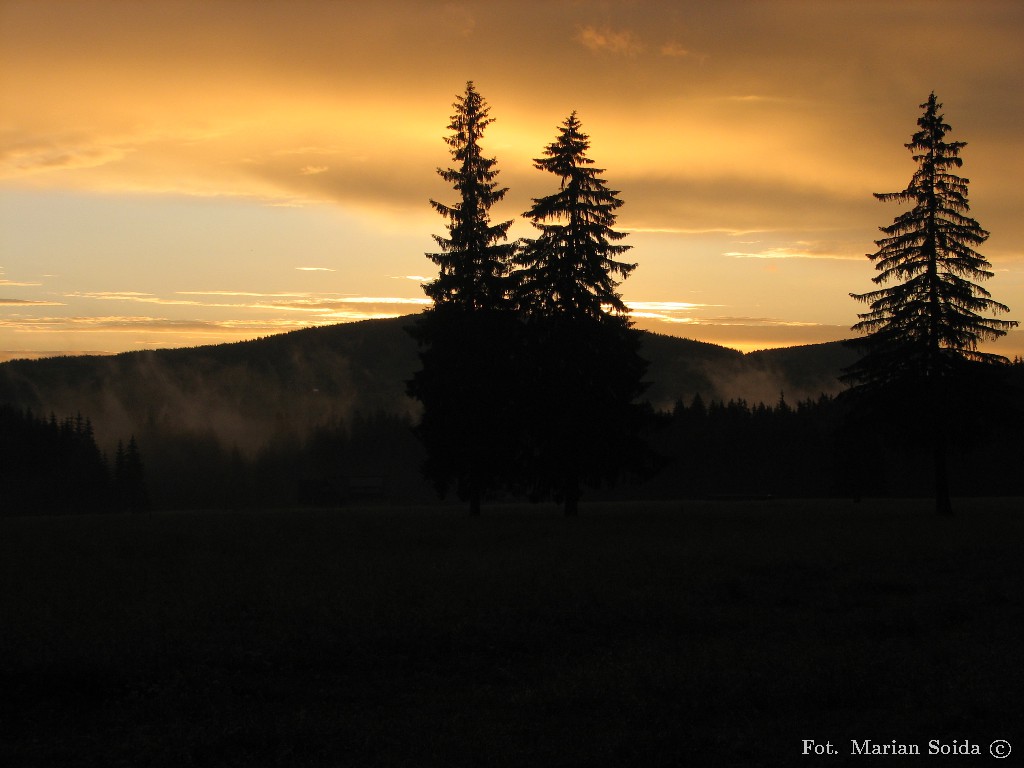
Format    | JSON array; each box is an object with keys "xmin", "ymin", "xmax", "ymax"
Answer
[{"xmin": 515, "ymin": 112, "xmax": 647, "ymax": 516}]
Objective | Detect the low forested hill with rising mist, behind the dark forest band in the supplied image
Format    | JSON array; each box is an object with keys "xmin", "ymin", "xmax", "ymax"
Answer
[{"xmin": 0, "ymin": 316, "xmax": 852, "ymax": 450}]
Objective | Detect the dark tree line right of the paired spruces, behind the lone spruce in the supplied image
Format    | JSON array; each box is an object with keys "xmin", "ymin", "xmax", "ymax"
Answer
[{"xmin": 647, "ymin": 385, "xmax": 1024, "ymax": 501}]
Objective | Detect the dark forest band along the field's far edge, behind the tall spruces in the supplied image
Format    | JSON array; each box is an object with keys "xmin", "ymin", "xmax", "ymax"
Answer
[{"xmin": 0, "ymin": 361, "xmax": 1024, "ymax": 514}]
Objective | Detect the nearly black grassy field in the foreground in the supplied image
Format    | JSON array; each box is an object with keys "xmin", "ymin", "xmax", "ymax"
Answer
[{"xmin": 0, "ymin": 500, "xmax": 1024, "ymax": 768}]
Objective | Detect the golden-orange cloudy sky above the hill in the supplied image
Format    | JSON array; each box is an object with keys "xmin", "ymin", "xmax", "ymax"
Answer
[{"xmin": 0, "ymin": 0, "xmax": 1024, "ymax": 359}]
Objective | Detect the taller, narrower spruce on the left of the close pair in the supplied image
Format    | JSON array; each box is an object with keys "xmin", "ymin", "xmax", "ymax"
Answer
[{"xmin": 408, "ymin": 81, "xmax": 515, "ymax": 515}]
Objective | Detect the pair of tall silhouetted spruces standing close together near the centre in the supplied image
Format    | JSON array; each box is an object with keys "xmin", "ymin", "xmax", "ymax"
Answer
[{"xmin": 409, "ymin": 82, "xmax": 649, "ymax": 515}]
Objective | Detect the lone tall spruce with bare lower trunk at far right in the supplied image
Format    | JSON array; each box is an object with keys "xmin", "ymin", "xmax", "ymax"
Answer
[{"xmin": 843, "ymin": 92, "xmax": 1017, "ymax": 515}]
